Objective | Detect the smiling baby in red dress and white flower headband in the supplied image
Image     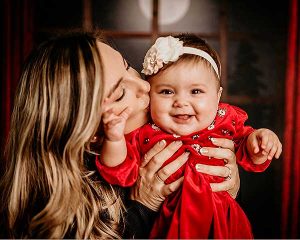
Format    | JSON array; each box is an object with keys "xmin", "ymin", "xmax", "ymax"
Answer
[{"xmin": 96, "ymin": 34, "xmax": 282, "ymax": 238}]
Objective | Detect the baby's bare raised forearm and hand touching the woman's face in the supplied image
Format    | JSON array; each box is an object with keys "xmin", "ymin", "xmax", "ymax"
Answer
[{"xmin": 100, "ymin": 107, "xmax": 131, "ymax": 167}]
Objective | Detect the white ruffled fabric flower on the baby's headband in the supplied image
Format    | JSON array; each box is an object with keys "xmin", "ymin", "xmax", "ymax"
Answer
[{"xmin": 142, "ymin": 36, "xmax": 183, "ymax": 75}]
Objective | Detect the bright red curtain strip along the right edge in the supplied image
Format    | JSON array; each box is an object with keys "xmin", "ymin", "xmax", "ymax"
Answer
[{"xmin": 282, "ymin": 0, "xmax": 300, "ymax": 238}]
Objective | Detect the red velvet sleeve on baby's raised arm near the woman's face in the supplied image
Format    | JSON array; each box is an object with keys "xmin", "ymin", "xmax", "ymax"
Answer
[{"xmin": 96, "ymin": 129, "xmax": 140, "ymax": 187}]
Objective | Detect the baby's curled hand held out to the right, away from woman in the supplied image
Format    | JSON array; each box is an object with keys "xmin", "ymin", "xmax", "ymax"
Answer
[{"xmin": 247, "ymin": 128, "xmax": 282, "ymax": 164}]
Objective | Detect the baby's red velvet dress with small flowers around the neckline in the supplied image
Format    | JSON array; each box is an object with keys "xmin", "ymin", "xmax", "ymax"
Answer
[{"xmin": 96, "ymin": 103, "xmax": 270, "ymax": 239}]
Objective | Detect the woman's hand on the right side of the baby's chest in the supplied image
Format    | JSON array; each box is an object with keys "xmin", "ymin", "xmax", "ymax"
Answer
[{"xmin": 196, "ymin": 138, "xmax": 240, "ymax": 198}]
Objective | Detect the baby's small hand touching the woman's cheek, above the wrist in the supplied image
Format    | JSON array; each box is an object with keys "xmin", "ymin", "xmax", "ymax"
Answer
[{"xmin": 102, "ymin": 107, "xmax": 131, "ymax": 142}]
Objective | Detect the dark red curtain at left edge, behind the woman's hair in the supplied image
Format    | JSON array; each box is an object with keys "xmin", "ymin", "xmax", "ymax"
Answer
[{"xmin": 0, "ymin": 0, "xmax": 34, "ymax": 151}]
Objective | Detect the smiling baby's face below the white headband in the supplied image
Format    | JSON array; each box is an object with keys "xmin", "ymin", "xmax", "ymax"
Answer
[{"xmin": 150, "ymin": 63, "xmax": 222, "ymax": 136}]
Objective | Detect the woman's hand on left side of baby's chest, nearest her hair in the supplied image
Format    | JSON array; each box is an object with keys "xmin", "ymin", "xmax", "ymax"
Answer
[{"xmin": 130, "ymin": 140, "xmax": 189, "ymax": 211}]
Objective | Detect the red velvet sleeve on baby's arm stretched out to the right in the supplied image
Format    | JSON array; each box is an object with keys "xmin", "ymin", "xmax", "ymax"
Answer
[{"xmin": 232, "ymin": 106, "xmax": 271, "ymax": 172}]
